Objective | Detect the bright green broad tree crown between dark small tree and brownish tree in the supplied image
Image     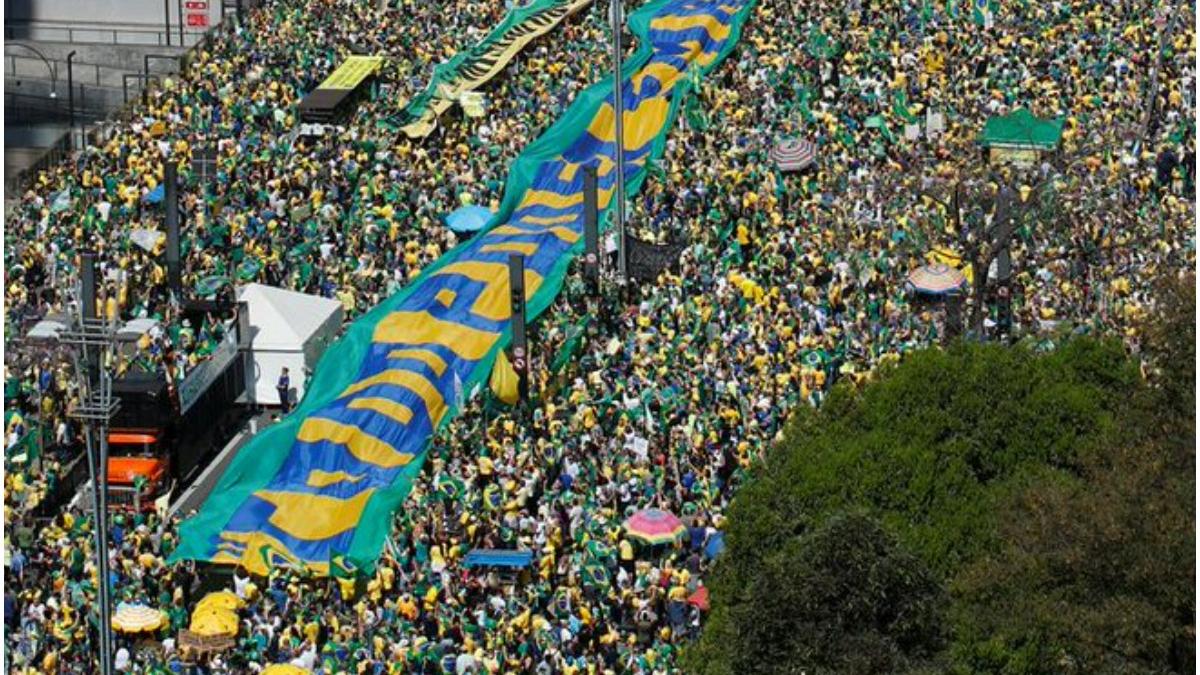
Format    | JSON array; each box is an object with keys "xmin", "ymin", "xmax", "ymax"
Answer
[{"xmin": 705, "ymin": 339, "xmax": 1139, "ymax": 585}]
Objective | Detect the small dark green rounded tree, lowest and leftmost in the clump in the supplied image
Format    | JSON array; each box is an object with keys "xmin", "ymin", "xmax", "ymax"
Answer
[{"xmin": 688, "ymin": 514, "xmax": 943, "ymax": 674}]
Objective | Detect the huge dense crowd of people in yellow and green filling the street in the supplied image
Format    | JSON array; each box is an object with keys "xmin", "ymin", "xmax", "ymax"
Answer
[{"xmin": 5, "ymin": 0, "xmax": 1195, "ymax": 674}]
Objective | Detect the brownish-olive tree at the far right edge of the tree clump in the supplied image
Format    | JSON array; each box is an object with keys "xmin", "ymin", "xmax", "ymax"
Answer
[{"xmin": 955, "ymin": 279, "xmax": 1195, "ymax": 673}]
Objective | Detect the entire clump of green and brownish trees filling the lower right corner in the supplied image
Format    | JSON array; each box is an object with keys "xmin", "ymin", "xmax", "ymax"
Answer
[{"xmin": 686, "ymin": 290, "xmax": 1195, "ymax": 674}]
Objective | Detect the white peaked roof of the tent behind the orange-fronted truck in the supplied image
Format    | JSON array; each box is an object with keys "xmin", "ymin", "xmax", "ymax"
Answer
[{"xmin": 238, "ymin": 283, "xmax": 342, "ymax": 350}]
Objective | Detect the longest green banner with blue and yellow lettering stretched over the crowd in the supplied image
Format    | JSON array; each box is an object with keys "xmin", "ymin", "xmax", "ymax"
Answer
[{"xmin": 173, "ymin": 0, "xmax": 754, "ymax": 575}]
